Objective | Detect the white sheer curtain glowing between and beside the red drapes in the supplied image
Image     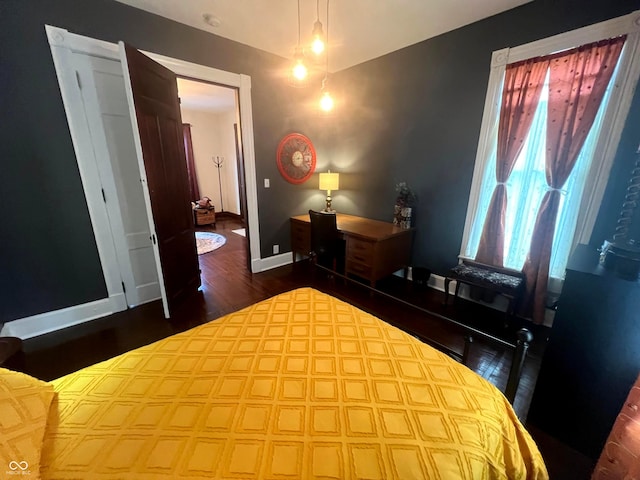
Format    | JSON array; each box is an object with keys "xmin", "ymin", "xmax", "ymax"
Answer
[{"xmin": 464, "ymin": 67, "xmax": 616, "ymax": 287}]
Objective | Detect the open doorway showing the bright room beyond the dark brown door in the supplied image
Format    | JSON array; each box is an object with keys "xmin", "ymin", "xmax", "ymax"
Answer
[{"xmin": 178, "ymin": 78, "xmax": 250, "ymax": 284}]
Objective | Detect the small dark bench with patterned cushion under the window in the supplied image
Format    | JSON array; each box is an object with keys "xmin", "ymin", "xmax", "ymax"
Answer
[{"xmin": 444, "ymin": 259, "xmax": 525, "ymax": 318}]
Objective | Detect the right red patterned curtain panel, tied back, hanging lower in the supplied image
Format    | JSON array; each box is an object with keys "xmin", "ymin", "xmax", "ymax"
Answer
[{"xmin": 523, "ymin": 36, "xmax": 626, "ymax": 323}]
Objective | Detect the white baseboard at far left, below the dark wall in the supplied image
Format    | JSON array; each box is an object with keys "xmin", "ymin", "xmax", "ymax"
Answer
[{"xmin": 0, "ymin": 298, "xmax": 126, "ymax": 340}]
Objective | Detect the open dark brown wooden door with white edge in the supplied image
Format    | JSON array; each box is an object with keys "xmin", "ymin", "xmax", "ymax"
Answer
[{"xmin": 120, "ymin": 42, "xmax": 200, "ymax": 316}]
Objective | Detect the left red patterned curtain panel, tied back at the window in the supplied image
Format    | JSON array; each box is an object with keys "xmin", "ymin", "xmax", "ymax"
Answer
[{"xmin": 475, "ymin": 57, "xmax": 549, "ymax": 267}]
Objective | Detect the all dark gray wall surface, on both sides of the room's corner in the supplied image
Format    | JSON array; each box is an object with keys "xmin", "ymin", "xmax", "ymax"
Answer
[{"xmin": 0, "ymin": 0, "xmax": 640, "ymax": 321}]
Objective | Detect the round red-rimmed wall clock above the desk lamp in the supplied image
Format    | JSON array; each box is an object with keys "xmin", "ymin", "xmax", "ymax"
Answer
[{"xmin": 276, "ymin": 133, "xmax": 316, "ymax": 184}]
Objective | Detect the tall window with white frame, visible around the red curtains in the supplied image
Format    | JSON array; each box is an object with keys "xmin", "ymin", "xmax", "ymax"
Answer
[{"xmin": 461, "ymin": 14, "xmax": 638, "ymax": 291}]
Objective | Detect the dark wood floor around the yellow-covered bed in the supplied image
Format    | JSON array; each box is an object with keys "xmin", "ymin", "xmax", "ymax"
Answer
[{"xmin": 13, "ymin": 216, "xmax": 593, "ymax": 479}]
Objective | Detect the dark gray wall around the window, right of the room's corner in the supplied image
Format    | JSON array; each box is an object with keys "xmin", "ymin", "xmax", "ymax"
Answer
[{"xmin": 324, "ymin": 0, "xmax": 640, "ymax": 274}]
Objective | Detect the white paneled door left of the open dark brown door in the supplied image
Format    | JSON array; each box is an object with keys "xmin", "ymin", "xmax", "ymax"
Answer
[{"xmin": 73, "ymin": 53, "xmax": 160, "ymax": 307}]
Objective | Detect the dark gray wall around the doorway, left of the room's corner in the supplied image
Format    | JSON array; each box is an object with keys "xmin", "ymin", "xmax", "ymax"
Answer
[{"xmin": 0, "ymin": 0, "xmax": 320, "ymax": 321}]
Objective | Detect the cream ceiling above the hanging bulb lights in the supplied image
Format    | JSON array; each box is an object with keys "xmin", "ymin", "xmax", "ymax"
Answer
[{"xmin": 117, "ymin": 0, "xmax": 531, "ymax": 72}]
